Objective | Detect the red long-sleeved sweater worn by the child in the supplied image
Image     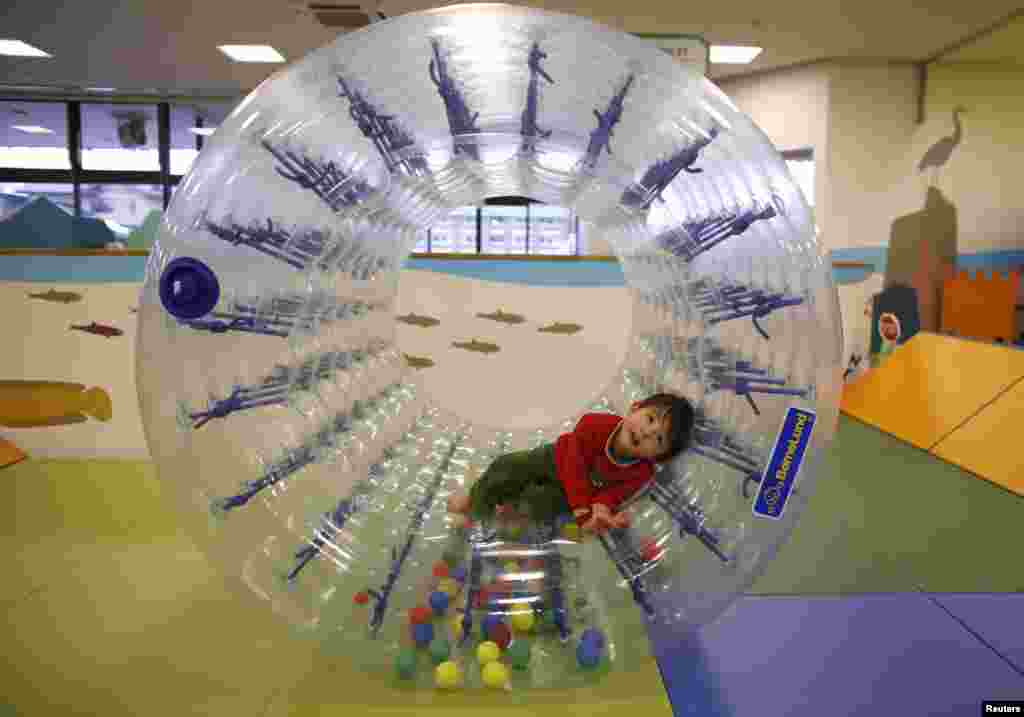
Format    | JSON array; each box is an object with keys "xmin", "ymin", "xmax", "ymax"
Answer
[{"xmin": 555, "ymin": 413, "xmax": 654, "ymax": 512}]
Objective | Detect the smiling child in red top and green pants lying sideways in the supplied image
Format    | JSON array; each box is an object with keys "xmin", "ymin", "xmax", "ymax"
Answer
[{"xmin": 447, "ymin": 393, "xmax": 693, "ymax": 533}]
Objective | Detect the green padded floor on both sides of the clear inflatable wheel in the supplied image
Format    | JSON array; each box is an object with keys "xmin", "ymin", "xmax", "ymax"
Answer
[{"xmin": 0, "ymin": 418, "xmax": 1024, "ymax": 717}]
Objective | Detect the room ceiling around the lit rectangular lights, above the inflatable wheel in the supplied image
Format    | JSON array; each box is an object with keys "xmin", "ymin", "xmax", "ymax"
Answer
[{"xmin": 0, "ymin": 0, "xmax": 1024, "ymax": 96}]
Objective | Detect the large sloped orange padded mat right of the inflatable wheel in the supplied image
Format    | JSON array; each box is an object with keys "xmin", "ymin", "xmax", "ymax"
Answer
[{"xmin": 841, "ymin": 332, "xmax": 1024, "ymax": 451}]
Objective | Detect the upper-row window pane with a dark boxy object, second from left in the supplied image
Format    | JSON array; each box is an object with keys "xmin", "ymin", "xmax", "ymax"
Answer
[{"xmin": 82, "ymin": 103, "xmax": 160, "ymax": 172}]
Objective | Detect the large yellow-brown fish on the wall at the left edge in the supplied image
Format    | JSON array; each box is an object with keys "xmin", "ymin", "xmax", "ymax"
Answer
[{"xmin": 0, "ymin": 381, "xmax": 114, "ymax": 428}]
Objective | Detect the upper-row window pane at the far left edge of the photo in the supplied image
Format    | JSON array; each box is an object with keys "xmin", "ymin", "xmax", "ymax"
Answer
[{"xmin": 0, "ymin": 100, "xmax": 71, "ymax": 170}]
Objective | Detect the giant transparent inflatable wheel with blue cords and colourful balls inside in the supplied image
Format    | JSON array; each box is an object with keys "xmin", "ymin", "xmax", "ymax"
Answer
[{"xmin": 138, "ymin": 4, "xmax": 841, "ymax": 688}]
